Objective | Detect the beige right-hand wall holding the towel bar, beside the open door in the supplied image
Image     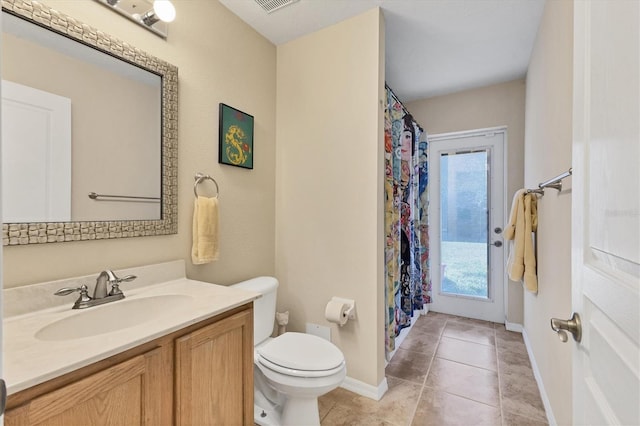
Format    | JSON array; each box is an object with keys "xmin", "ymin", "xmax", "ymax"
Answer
[{"xmin": 524, "ymin": 0, "xmax": 573, "ymax": 425}]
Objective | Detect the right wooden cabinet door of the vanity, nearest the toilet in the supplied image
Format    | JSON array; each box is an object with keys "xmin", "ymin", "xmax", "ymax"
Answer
[{"xmin": 175, "ymin": 309, "xmax": 253, "ymax": 426}]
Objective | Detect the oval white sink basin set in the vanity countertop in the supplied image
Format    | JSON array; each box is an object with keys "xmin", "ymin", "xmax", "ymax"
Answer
[{"xmin": 35, "ymin": 294, "xmax": 193, "ymax": 340}]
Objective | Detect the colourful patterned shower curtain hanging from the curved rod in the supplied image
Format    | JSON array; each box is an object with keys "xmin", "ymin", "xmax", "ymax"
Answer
[{"xmin": 384, "ymin": 87, "xmax": 431, "ymax": 358}]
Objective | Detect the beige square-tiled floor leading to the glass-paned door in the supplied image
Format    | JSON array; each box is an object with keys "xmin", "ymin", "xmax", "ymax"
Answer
[{"xmin": 318, "ymin": 312, "xmax": 547, "ymax": 426}]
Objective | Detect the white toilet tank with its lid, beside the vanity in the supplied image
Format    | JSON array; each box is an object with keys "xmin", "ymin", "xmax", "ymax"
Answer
[{"xmin": 230, "ymin": 277, "xmax": 278, "ymax": 346}]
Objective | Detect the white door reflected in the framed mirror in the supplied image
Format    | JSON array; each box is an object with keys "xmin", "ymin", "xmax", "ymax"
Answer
[{"xmin": 2, "ymin": 80, "xmax": 71, "ymax": 223}]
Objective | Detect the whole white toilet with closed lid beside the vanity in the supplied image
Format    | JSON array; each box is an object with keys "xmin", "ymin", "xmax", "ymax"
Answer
[{"xmin": 232, "ymin": 277, "xmax": 347, "ymax": 426}]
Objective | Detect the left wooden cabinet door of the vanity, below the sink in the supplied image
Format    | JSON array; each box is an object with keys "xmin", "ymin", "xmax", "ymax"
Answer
[{"xmin": 4, "ymin": 348, "xmax": 171, "ymax": 426}]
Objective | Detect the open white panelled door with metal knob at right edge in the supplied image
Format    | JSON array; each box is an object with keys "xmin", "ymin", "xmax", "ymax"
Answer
[{"xmin": 569, "ymin": 0, "xmax": 640, "ymax": 425}]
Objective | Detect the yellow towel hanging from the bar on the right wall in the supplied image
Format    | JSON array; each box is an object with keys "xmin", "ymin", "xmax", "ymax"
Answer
[{"xmin": 504, "ymin": 189, "xmax": 538, "ymax": 293}]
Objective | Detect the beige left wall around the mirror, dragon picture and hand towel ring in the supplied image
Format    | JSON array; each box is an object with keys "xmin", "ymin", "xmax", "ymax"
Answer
[{"xmin": 3, "ymin": 0, "xmax": 276, "ymax": 287}]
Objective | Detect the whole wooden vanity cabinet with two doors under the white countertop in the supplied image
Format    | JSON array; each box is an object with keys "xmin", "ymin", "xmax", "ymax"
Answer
[{"xmin": 4, "ymin": 304, "xmax": 253, "ymax": 426}]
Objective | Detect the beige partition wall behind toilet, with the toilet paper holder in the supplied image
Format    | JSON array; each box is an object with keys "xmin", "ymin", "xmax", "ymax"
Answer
[{"xmin": 276, "ymin": 9, "xmax": 384, "ymax": 387}]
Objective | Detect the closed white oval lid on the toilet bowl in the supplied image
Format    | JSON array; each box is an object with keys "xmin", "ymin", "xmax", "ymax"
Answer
[{"xmin": 258, "ymin": 332, "xmax": 344, "ymax": 371}]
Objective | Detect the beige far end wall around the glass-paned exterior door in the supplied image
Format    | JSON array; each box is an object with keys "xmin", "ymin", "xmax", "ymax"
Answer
[{"xmin": 405, "ymin": 80, "xmax": 525, "ymax": 324}]
